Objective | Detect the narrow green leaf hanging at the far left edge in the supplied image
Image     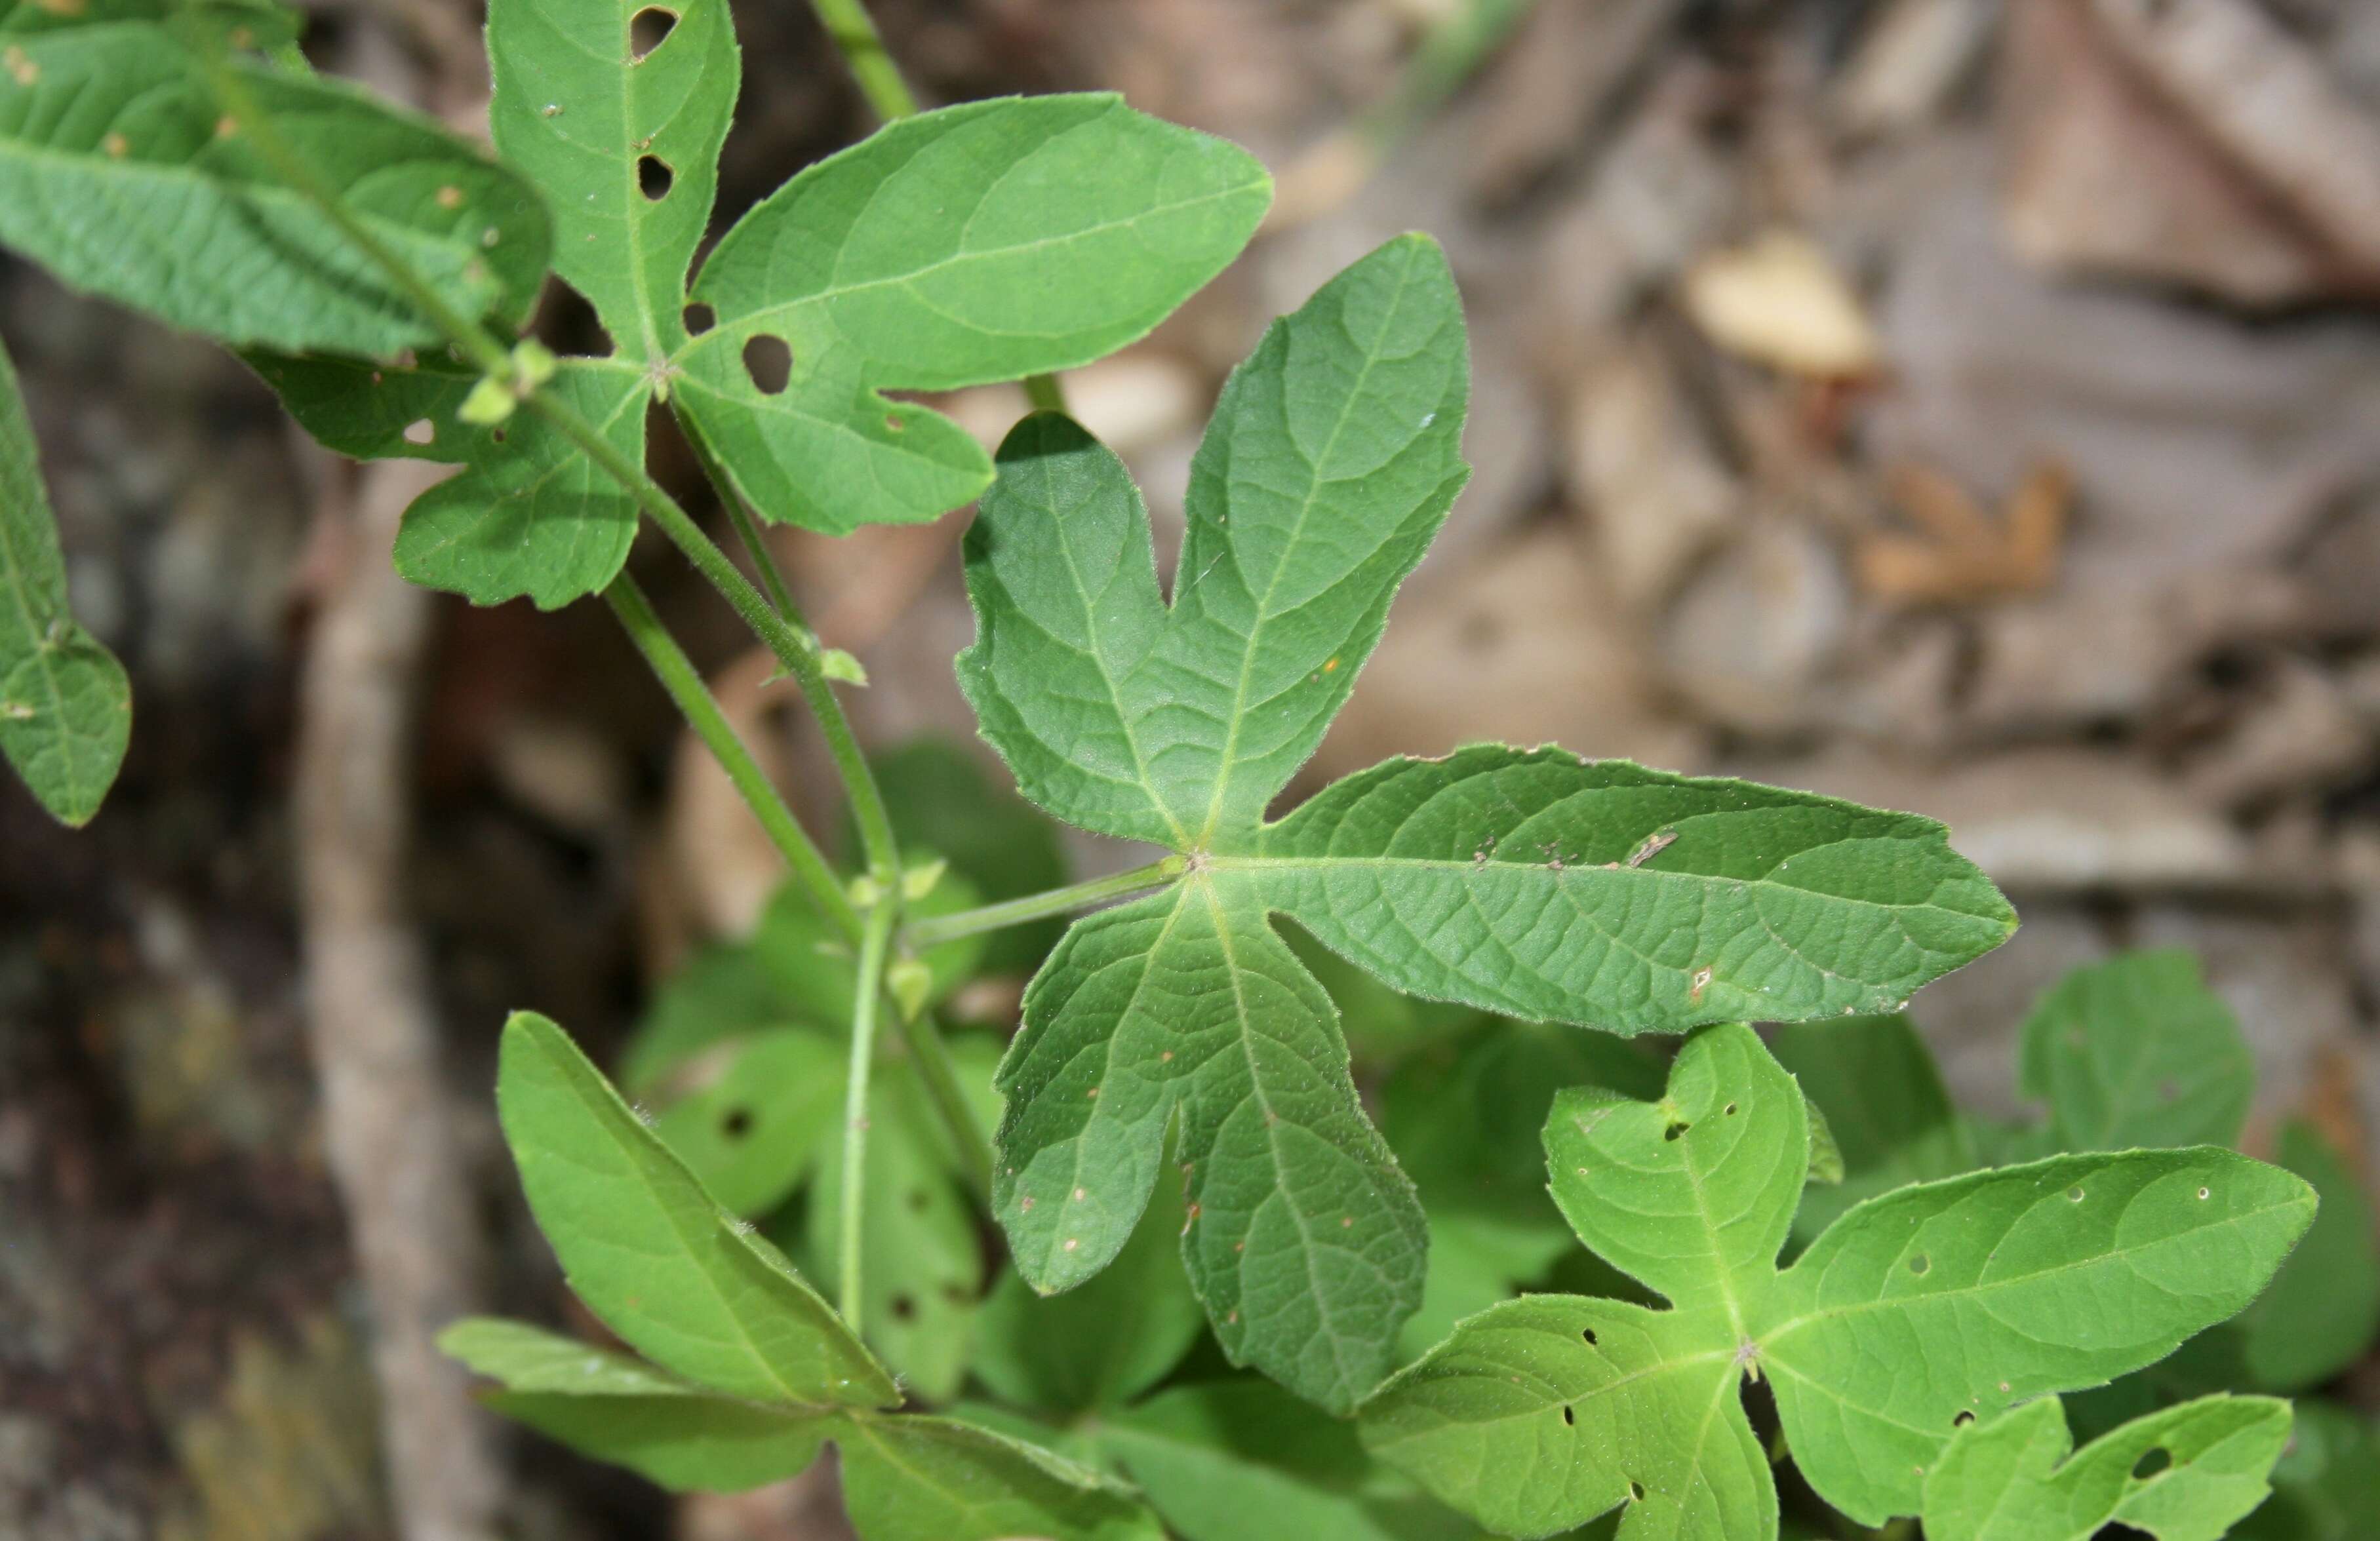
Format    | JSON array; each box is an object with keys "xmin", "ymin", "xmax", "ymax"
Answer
[{"xmin": 0, "ymin": 330, "xmax": 133, "ymax": 825}]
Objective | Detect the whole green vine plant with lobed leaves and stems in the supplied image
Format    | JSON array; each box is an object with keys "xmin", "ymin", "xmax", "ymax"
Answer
[{"xmin": 0, "ymin": 0, "xmax": 2368, "ymax": 1541}]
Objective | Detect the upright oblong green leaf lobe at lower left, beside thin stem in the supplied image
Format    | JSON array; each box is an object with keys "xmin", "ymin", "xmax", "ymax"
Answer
[{"xmin": 495, "ymin": 1013, "xmax": 900, "ymax": 1410}]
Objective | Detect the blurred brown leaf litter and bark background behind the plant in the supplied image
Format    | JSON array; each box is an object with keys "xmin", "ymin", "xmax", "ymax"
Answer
[{"xmin": 0, "ymin": 0, "xmax": 2380, "ymax": 1541}]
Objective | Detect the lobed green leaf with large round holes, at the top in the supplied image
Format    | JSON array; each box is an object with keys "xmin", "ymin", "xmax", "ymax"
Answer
[{"xmin": 260, "ymin": 79, "xmax": 1271, "ymax": 609}]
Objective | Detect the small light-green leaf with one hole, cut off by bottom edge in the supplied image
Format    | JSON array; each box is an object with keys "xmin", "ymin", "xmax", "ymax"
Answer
[{"xmin": 1926, "ymin": 1396, "xmax": 2290, "ymax": 1541}]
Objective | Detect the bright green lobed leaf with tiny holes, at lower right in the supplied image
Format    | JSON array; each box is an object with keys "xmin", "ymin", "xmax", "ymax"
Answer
[{"xmin": 1364, "ymin": 1025, "xmax": 2313, "ymax": 1541}]
